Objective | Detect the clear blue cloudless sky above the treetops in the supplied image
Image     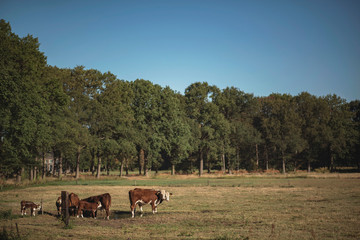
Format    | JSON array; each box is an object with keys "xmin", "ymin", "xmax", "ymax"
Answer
[{"xmin": 0, "ymin": 0, "xmax": 360, "ymax": 101}]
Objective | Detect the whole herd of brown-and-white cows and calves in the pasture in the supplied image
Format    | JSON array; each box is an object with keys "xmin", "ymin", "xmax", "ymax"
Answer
[{"xmin": 20, "ymin": 188, "xmax": 172, "ymax": 220}]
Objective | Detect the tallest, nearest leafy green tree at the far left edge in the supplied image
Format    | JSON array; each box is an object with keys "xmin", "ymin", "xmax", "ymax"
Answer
[{"xmin": 0, "ymin": 20, "xmax": 65, "ymax": 180}]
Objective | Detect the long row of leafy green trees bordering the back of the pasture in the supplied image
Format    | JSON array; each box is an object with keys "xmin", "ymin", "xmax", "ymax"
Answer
[{"xmin": 0, "ymin": 20, "xmax": 360, "ymax": 179}]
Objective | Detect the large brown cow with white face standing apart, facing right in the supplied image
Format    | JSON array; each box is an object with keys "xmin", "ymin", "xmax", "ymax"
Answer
[{"xmin": 129, "ymin": 188, "xmax": 172, "ymax": 217}]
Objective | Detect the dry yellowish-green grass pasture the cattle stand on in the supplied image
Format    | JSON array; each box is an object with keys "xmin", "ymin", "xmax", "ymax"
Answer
[{"xmin": 0, "ymin": 174, "xmax": 360, "ymax": 239}]
